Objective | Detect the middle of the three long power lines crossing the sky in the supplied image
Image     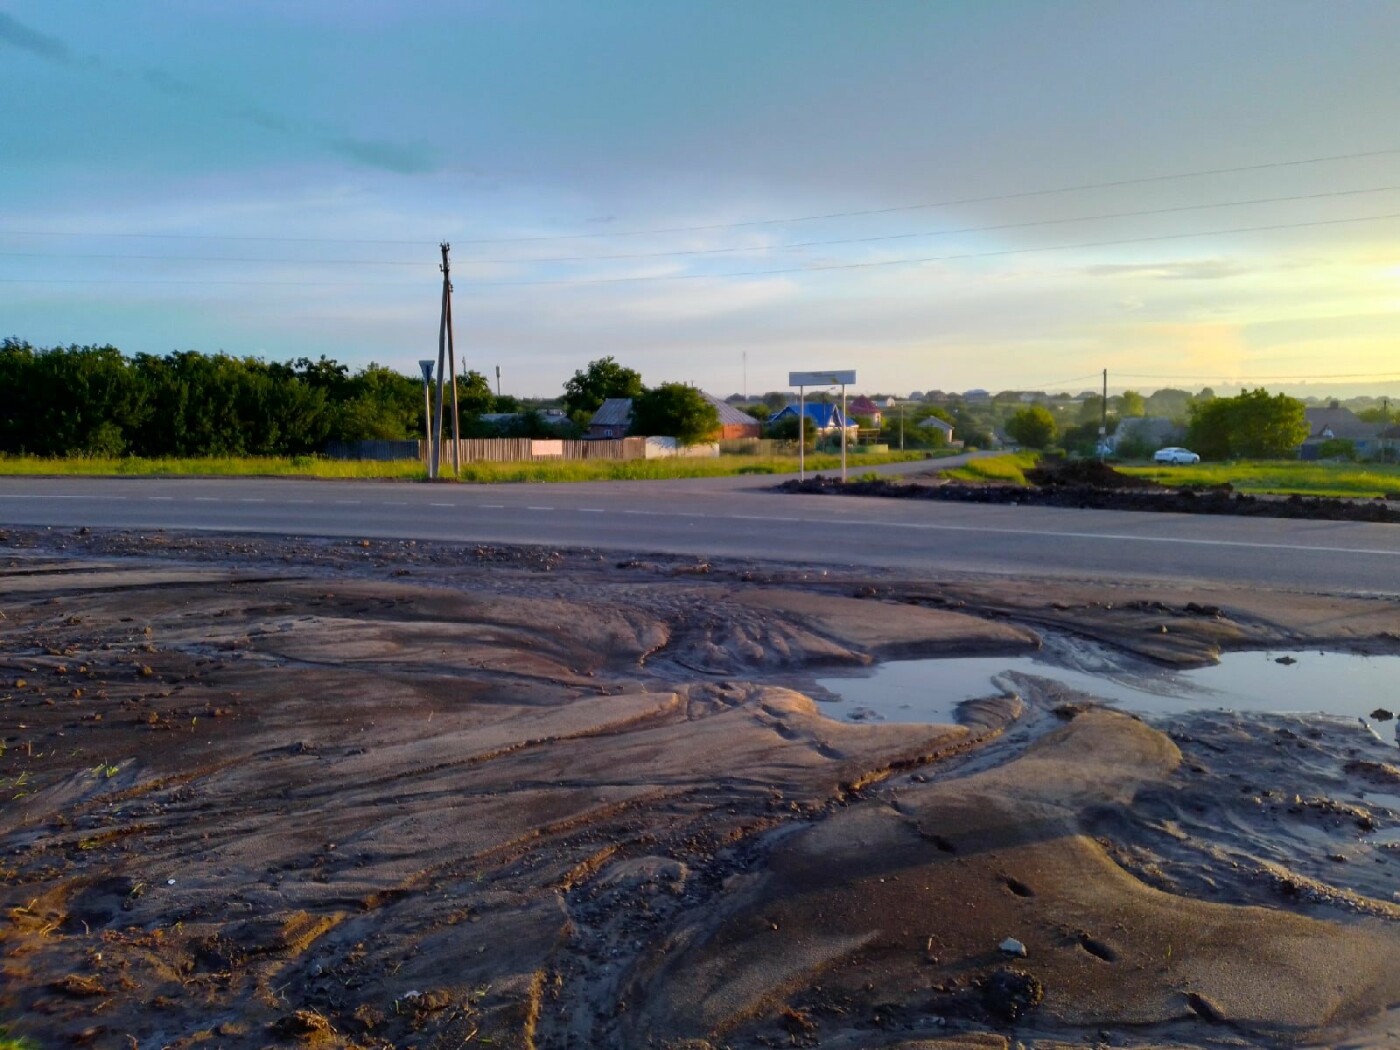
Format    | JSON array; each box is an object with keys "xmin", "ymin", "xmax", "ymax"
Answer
[{"xmin": 0, "ymin": 185, "xmax": 1400, "ymax": 266}]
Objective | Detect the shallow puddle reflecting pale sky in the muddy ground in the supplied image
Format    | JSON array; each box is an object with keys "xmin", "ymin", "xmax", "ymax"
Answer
[{"xmin": 816, "ymin": 651, "xmax": 1400, "ymax": 741}]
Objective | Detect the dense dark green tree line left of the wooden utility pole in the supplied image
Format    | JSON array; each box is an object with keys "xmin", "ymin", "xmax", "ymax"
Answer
[{"xmin": 0, "ymin": 337, "xmax": 494, "ymax": 456}]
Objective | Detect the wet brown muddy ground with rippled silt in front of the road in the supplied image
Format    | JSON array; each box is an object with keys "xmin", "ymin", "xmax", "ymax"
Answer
[{"xmin": 0, "ymin": 531, "xmax": 1400, "ymax": 1050}]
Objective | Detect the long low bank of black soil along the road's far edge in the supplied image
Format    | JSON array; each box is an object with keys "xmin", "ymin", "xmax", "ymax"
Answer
[{"xmin": 777, "ymin": 461, "xmax": 1400, "ymax": 522}]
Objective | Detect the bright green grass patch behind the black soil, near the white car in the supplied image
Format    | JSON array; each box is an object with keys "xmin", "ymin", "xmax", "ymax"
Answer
[{"xmin": 1114, "ymin": 459, "xmax": 1400, "ymax": 498}]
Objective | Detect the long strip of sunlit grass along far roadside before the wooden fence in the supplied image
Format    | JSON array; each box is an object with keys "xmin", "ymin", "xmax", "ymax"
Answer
[{"xmin": 0, "ymin": 452, "xmax": 924, "ymax": 484}]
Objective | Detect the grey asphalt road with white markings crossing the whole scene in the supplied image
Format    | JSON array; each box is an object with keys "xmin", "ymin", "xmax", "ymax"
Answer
[{"xmin": 0, "ymin": 477, "xmax": 1400, "ymax": 596}]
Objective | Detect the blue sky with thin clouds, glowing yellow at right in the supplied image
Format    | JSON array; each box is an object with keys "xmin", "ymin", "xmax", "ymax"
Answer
[{"xmin": 0, "ymin": 0, "xmax": 1400, "ymax": 396}]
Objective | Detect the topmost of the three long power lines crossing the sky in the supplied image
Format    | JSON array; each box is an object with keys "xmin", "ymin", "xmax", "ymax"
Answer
[{"xmin": 0, "ymin": 148, "xmax": 1400, "ymax": 246}]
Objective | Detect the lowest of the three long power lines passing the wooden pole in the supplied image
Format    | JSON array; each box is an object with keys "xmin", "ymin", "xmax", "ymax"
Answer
[{"xmin": 0, "ymin": 211, "xmax": 1400, "ymax": 290}]
